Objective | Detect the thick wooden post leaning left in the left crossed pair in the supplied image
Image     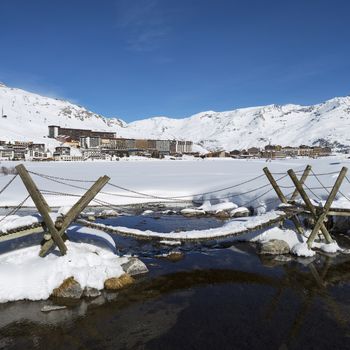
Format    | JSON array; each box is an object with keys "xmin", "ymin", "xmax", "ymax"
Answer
[{"xmin": 16, "ymin": 164, "xmax": 67, "ymax": 255}]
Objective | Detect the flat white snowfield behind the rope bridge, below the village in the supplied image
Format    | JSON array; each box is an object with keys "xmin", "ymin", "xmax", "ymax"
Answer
[{"xmin": 0, "ymin": 155, "xmax": 350, "ymax": 209}]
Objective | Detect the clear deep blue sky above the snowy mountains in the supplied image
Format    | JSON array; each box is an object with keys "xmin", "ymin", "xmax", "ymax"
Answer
[{"xmin": 0, "ymin": 0, "xmax": 350, "ymax": 121}]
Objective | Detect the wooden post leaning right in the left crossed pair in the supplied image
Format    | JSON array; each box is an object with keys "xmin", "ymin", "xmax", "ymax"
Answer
[{"xmin": 39, "ymin": 176, "xmax": 110, "ymax": 257}]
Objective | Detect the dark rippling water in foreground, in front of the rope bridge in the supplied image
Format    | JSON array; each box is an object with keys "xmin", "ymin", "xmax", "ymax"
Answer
[{"xmin": 0, "ymin": 212, "xmax": 350, "ymax": 349}]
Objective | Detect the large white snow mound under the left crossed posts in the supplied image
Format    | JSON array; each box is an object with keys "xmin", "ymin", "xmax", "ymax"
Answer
[{"xmin": 0, "ymin": 241, "xmax": 127, "ymax": 303}]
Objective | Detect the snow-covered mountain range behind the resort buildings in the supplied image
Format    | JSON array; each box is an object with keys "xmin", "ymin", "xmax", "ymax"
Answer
[{"xmin": 0, "ymin": 83, "xmax": 350, "ymax": 150}]
